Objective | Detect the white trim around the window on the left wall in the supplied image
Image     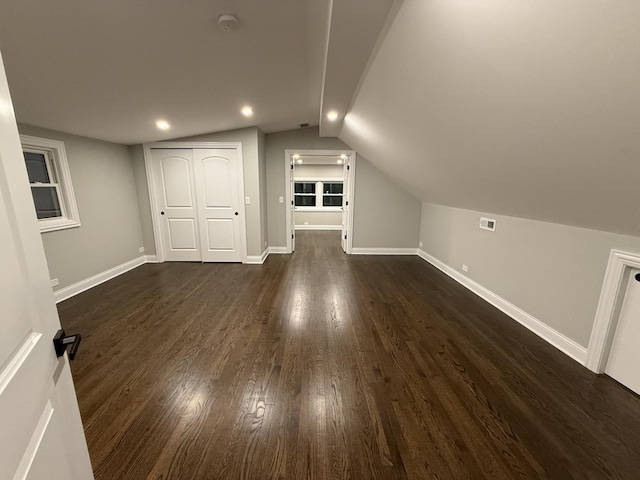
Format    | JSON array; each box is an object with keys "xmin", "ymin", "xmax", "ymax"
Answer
[{"xmin": 20, "ymin": 135, "xmax": 80, "ymax": 233}]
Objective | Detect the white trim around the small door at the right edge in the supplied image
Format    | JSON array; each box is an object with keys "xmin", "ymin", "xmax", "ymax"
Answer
[{"xmin": 586, "ymin": 250, "xmax": 640, "ymax": 373}]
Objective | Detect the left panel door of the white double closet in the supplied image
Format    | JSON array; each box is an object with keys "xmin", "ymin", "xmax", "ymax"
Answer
[{"xmin": 151, "ymin": 148, "xmax": 202, "ymax": 261}]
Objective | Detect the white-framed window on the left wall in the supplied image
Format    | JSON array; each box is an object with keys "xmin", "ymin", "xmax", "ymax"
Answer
[{"xmin": 20, "ymin": 135, "xmax": 80, "ymax": 232}]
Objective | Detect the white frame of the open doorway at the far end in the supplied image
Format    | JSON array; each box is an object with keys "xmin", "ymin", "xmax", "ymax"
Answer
[{"xmin": 284, "ymin": 148, "xmax": 357, "ymax": 254}]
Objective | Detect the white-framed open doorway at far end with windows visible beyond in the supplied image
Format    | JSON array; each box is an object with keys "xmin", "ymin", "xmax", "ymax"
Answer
[{"xmin": 285, "ymin": 149, "xmax": 356, "ymax": 253}]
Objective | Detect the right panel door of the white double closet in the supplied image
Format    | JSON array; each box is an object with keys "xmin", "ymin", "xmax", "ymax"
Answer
[{"xmin": 193, "ymin": 148, "xmax": 244, "ymax": 262}]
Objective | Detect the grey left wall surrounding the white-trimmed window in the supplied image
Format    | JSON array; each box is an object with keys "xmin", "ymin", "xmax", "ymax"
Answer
[{"xmin": 18, "ymin": 125, "xmax": 143, "ymax": 290}]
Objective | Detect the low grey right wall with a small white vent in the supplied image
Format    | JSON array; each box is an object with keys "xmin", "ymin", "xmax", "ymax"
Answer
[{"xmin": 420, "ymin": 203, "xmax": 640, "ymax": 347}]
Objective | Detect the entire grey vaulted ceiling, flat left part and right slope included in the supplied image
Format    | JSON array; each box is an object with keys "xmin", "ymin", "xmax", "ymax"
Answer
[{"xmin": 0, "ymin": 0, "xmax": 640, "ymax": 236}]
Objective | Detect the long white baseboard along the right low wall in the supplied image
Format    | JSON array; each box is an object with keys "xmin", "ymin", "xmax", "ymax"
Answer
[{"xmin": 418, "ymin": 249, "xmax": 587, "ymax": 365}]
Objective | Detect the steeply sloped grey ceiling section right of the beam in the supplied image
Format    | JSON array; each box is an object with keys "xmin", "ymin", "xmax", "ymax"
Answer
[{"xmin": 339, "ymin": 0, "xmax": 640, "ymax": 236}]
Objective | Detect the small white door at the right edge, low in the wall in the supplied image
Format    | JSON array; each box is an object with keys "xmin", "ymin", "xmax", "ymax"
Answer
[{"xmin": 605, "ymin": 269, "xmax": 640, "ymax": 395}]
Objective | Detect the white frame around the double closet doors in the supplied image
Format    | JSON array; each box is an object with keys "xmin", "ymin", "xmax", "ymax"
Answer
[{"xmin": 142, "ymin": 142, "xmax": 247, "ymax": 263}]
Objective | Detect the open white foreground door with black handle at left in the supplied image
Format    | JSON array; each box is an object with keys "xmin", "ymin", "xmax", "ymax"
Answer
[{"xmin": 0, "ymin": 50, "xmax": 93, "ymax": 480}]
